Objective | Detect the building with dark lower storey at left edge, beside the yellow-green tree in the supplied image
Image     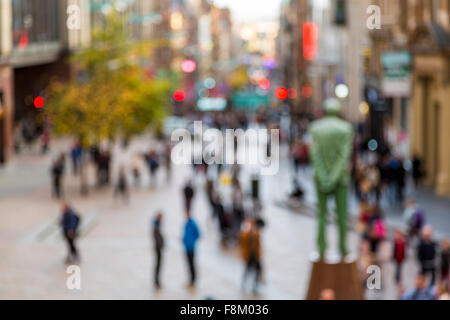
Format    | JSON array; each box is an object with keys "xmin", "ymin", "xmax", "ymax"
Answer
[{"xmin": 0, "ymin": 0, "xmax": 90, "ymax": 163}]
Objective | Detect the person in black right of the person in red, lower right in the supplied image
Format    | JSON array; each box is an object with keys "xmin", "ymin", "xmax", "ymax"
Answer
[{"xmin": 417, "ymin": 226, "xmax": 436, "ymax": 286}]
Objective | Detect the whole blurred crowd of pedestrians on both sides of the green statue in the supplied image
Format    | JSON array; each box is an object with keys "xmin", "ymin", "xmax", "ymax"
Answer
[{"xmin": 29, "ymin": 109, "xmax": 450, "ymax": 299}]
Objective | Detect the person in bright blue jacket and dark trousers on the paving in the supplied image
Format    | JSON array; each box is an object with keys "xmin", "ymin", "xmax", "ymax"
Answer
[{"xmin": 183, "ymin": 210, "xmax": 200, "ymax": 288}]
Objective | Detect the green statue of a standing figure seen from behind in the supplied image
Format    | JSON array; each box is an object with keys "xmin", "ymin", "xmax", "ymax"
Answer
[{"xmin": 310, "ymin": 99, "xmax": 353, "ymax": 259}]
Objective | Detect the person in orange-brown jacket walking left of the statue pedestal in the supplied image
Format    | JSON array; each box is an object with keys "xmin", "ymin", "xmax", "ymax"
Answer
[{"xmin": 239, "ymin": 218, "xmax": 262, "ymax": 294}]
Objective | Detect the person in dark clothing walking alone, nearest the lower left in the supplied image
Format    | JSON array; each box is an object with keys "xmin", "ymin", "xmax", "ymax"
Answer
[{"xmin": 61, "ymin": 202, "xmax": 80, "ymax": 264}]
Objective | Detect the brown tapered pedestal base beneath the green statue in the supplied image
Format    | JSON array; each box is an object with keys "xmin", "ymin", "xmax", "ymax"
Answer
[{"xmin": 306, "ymin": 255, "xmax": 364, "ymax": 300}]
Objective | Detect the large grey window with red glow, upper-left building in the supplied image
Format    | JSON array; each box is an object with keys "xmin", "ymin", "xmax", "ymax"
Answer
[{"xmin": 12, "ymin": 0, "xmax": 60, "ymax": 48}]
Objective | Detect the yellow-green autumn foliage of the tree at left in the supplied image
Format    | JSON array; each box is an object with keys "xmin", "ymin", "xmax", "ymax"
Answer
[{"xmin": 46, "ymin": 8, "xmax": 171, "ymax": 146}]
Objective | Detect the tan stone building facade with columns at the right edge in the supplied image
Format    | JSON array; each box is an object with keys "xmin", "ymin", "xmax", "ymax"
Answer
[{"xmin": 371, "ymin": 0, "xmax": 450, "ymax": 195}]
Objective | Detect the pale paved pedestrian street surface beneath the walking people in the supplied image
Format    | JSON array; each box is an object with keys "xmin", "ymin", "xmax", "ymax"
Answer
[{"xmin": 0, "ymin": 138, "xmax": 422, "ymax": 299}]
